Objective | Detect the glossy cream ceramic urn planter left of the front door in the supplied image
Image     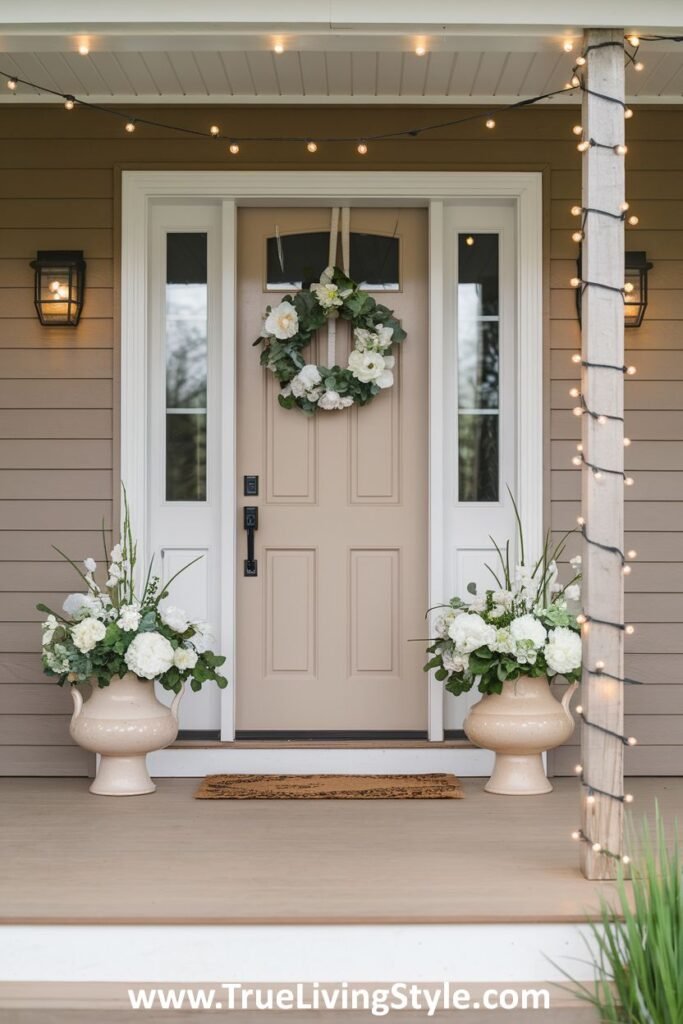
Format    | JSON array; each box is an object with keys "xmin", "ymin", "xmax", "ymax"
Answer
[{"xmin": 70, "ymin": 672, "xmax": 182, "ymax": 797}]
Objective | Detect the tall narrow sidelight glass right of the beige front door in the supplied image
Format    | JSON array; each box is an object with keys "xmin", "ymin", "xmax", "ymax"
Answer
[{"xmin": 457, "ymin": 233, "xmax": 501, "ymax": 502}]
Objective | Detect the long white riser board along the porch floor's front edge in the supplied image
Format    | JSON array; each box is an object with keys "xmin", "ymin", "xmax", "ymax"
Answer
[{"xmin": 0, "ymin": 924, "xmax": 593, "ymax": 984}]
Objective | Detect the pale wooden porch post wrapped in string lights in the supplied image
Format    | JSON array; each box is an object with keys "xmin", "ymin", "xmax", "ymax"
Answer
[{"xmin": 581, "ymin": 29, "xmax": 625, "ymax": 879}]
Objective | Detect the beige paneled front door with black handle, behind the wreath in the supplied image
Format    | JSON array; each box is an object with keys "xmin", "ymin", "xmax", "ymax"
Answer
[{"xmin": 237, "ymin": 208, "xmax": 428, "ymax": 734}]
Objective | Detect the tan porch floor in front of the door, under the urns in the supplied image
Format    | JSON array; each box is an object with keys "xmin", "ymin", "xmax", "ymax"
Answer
[{"xmin": 0, "ymin": 778, "xmax": 683, "ymax": 924}]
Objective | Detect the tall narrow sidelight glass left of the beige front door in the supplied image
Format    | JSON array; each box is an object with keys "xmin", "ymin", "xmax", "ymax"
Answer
[{"xmin": 165, "ymin": 231, "xmax": 208, "ymax": 502}]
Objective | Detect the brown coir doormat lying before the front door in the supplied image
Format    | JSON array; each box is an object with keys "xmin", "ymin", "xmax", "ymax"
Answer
[{"xmin": 195, "ymin": 772, "xmax": 465, "ymax": 800}]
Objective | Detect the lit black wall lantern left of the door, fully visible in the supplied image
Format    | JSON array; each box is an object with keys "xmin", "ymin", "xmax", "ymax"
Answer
[{"xmin": 31, "ymin": 249, "xmax": 85, "ymax": 327}]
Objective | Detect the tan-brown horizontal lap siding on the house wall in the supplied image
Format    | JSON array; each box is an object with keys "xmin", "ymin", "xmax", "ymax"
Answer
[{"xmin": 0, "ymin": 106, "xmax": 683, "ymax": 774}]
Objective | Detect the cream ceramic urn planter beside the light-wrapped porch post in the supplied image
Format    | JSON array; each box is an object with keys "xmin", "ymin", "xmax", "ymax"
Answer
[{"xmin": 464, "ymin": 676, "xmax": 579, "ymax": 796}]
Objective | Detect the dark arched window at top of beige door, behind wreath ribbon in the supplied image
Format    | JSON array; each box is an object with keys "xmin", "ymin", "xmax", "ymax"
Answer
[{"xmin": 265, "ymin": 231, "xmax": 399, "ymax": 292}]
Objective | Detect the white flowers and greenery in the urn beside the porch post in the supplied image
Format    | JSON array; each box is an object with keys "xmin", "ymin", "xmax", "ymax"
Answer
[{"xmin": 425, "ymin": 495, "xmax": 582, "ymax": 694}]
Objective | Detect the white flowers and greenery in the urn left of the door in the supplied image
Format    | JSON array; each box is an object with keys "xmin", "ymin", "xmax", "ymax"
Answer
[{"xmin": 38, "ymin": 490, "xmax": 227, "ymax": 693}]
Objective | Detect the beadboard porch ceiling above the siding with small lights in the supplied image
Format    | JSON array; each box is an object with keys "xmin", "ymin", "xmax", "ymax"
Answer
[{"xmin": 0, "ymin": 35, "xmax": 683, "ymax": 104}]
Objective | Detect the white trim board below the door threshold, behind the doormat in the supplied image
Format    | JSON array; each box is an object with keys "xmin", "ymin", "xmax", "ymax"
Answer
[{"xmin": 147, "ymin": 746, "xmax": 494, "ymax": 778}]
